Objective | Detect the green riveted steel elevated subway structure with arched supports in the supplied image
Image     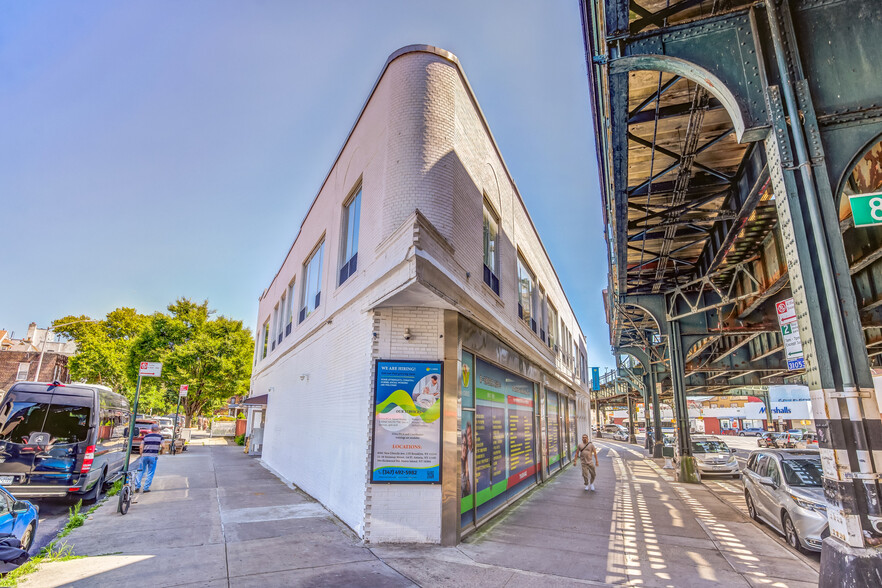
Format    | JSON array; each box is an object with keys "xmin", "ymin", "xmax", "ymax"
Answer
[{"xmin": 581, "ymin": 0, "xmax": 882, "ymax": 585}]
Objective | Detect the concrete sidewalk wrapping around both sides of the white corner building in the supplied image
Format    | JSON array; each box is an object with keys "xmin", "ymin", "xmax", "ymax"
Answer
[{"xmin": 21, "ymin": 442, "xmax": 818, "ymax": 588}]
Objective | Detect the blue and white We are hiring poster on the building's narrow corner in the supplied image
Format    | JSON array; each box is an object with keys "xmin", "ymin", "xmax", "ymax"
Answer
[{"xmin": 371, "ymin": 360, "xmax": 442, "ymax": 484}]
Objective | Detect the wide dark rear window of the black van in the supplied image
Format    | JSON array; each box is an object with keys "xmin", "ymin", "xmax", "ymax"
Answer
[{"xmin": 0, "ymin": 400, "xmax": 89, "ymax": 445}]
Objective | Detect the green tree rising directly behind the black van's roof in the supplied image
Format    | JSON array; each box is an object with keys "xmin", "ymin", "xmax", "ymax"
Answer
[{"xmin": 52, "ymin": 307, "xmax": 150, "ymax": 401}]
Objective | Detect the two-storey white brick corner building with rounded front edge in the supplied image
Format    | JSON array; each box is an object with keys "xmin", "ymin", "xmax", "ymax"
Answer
[{"xmin": 251, "ymin": 46, "xmax": 590, "ymax": 544}]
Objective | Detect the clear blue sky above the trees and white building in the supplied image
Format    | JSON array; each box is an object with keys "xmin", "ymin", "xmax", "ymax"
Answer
[{"xmin": 0, "ymin": 0, "xmax": 612, "ymax": 365}]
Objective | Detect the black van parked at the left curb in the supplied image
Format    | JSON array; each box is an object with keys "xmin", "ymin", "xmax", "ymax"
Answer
[{"xmin": 0, "ymin": 382, "xmax": 131, "ymax": 500}]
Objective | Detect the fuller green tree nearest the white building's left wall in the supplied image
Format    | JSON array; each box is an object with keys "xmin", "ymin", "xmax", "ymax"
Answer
[{"xmin": 129, "ymin": 298, "xmax": 254, "ymax": 427}]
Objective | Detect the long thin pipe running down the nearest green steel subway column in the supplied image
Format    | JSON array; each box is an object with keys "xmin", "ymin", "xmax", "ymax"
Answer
[{"xmin": 765, "ymin": 0, "xmax": 860, "ymax": 396}]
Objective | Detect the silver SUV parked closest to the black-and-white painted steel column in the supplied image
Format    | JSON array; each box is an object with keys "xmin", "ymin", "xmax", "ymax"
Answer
[{"xmin": 742, "ymin": 449, "xmax": 830, "ymax": 551}]
